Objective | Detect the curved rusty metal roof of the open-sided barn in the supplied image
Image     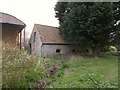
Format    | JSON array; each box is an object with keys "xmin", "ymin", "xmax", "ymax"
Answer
[{"xmin": 0, "ymin": 12, "xmax": 26, "ymax": 27}]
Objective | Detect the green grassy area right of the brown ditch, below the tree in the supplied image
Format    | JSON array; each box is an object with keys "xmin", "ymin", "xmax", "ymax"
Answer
[{"xmin": 47, "ymin": 55, "xmax": 118, "ymax": 88}]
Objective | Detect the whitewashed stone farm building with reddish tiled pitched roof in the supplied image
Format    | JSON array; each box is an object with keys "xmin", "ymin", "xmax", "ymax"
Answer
[{"xmin": 29, "ymin": 24, "xmax": 73, "ymax": 57}]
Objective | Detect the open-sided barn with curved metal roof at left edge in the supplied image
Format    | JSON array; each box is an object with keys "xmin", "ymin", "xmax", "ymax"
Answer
[{"xmin": 0, "ymin": 12, "xmax": 26, "ymax": 47}]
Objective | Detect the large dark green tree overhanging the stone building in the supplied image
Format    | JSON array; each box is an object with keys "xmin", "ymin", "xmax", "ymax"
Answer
[{"xmin": 55, "ymin": 2, "xmax": 119, "ymax": 56}]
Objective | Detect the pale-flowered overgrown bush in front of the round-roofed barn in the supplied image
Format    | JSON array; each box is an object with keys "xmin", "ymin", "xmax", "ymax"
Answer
[{"xmin": 2, "ymin": 47, "xmax": 47, "ymax": 88}]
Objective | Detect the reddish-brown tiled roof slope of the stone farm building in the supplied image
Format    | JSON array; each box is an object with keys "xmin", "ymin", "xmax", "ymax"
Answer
[{"xmin": 35, "ymin": 24, "xmax": 66, "ymax": 44}]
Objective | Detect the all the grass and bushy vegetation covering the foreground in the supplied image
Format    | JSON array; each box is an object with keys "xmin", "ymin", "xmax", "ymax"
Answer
[{"xmin": 2, "ymin": 44, "xmax": 118, "ymax": 89}]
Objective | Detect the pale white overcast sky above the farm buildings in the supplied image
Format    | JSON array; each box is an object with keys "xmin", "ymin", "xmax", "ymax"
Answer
[{"xmin": 0, "ymin": 0, "xmax": 59, "ymax": 32}]
